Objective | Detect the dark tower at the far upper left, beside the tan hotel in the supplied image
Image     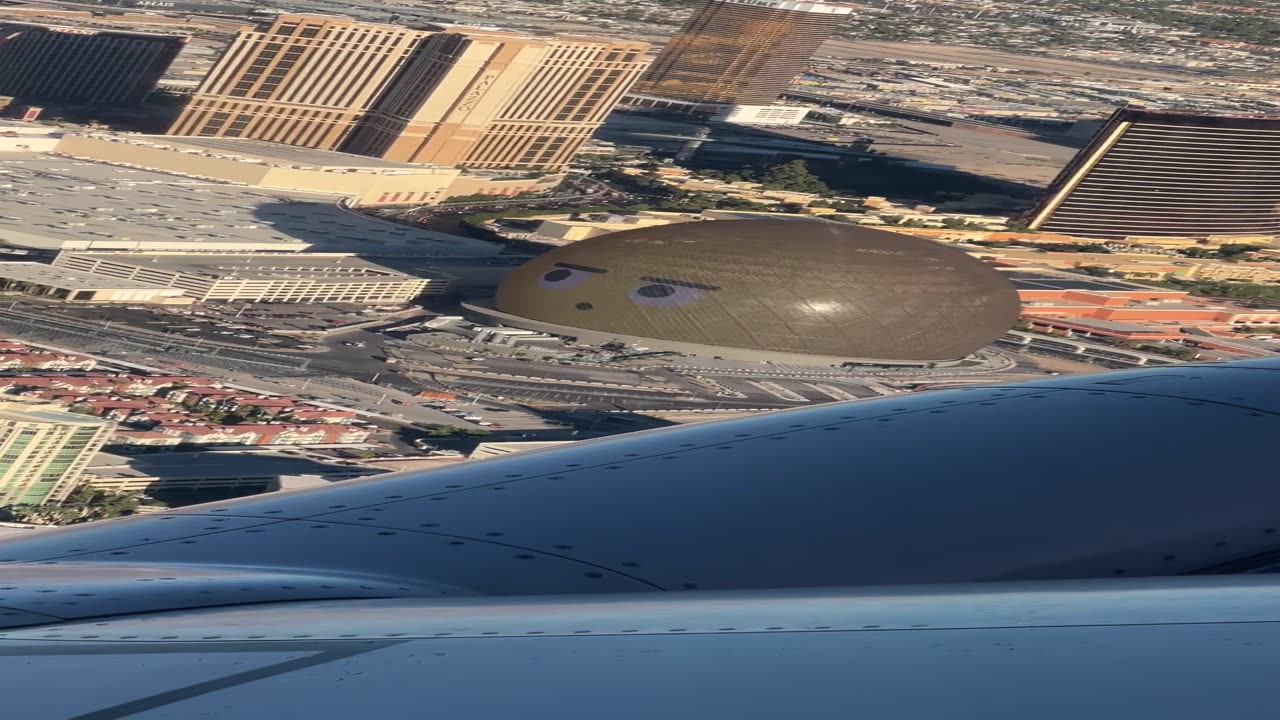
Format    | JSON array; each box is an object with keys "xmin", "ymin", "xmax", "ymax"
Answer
[{"xmin": 0, "ymin": 23, "xmax": 187, "ymax": 106}]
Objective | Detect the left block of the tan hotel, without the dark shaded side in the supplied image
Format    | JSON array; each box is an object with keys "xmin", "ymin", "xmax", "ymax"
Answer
[{"xmin": 168, "ymin": 14, "xmax": 431, "ymax": 150}]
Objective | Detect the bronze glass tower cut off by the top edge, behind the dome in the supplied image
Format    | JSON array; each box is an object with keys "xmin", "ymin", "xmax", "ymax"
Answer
[{"xmin": 632, "ymin": 0, "xmax": 852, "ymax": 105}]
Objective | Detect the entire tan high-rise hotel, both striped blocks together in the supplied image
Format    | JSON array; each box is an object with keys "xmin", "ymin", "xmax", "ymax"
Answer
[{"xmin": 168, "ymin": 14, "xmax": 649, "ymax": 170}]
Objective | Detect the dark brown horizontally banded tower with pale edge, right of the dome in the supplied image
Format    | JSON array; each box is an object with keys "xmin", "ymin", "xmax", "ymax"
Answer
[{"xmin": 1027, "ymin": 109, "xmax": 1280, "ymax": 240}]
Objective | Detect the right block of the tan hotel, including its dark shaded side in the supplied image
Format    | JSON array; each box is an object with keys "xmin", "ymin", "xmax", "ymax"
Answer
[{"xmin": 342, "ymin": 31, "xmax": 649, "ymax": 170}]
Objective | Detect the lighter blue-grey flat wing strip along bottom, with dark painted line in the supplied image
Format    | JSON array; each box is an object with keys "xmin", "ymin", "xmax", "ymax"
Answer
[{"xmin": 0, "ymin": 577, "xmax": 1280, "ymax": 720}]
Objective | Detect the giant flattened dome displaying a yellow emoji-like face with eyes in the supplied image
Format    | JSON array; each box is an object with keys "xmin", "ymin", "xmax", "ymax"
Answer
[{"xmin": 476, "ymin": 219, "xmax": 1019, "ymax": 363}]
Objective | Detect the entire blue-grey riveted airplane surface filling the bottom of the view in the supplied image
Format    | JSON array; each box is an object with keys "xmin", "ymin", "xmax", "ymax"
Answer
[{"xmin": 0, "ymin": 360, "xmax": 1280, "ymax": 720}]
